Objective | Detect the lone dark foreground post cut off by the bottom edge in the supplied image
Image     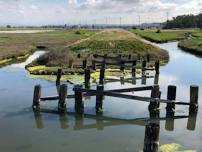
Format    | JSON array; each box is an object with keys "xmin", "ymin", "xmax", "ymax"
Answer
[{"xmin": 143, "ymin": 123, "xmax": 160, "ymax": 152}]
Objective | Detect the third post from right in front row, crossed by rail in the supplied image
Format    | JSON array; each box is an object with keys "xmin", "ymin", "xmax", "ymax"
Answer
[{"xmin": 149, "ymin": 85, "xmax": 160, "ymax": 112}]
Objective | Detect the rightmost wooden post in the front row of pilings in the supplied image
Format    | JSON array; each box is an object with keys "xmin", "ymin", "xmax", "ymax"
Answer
[{"xmin": 189, "ymin": 85, "xmax": 199, "ymax": 112}]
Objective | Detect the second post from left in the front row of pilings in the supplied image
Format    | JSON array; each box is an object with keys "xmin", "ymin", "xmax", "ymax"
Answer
[{"xmin": 58, "ymin": 84, "xmax": 67, "ymax": 112}]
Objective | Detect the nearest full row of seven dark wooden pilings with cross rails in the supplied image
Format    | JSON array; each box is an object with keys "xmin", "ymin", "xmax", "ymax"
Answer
[{"xmin": 32, "ymin": 84, "xmax": 199, "ymax": 114}]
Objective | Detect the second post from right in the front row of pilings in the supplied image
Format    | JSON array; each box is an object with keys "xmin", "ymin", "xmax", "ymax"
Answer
[{"xmin": 166, "ymin": 85, "xmax": 177, "ymax": 112}]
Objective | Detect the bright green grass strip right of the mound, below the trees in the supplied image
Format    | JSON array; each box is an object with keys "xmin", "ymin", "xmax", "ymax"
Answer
[{"xmin": 131, "ymin": 29, "xmax": 194, "ymax": 43}]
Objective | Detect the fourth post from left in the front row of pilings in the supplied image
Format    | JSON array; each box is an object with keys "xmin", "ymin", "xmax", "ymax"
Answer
[{"xmin": 95, "ymin": 85, "xmax": 104, "ymax": 112}]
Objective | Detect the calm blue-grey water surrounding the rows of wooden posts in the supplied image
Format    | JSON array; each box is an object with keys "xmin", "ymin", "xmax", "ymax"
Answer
[{"xmin": 0, "ymin": 42, "xmax": 202, "ymax": 152}]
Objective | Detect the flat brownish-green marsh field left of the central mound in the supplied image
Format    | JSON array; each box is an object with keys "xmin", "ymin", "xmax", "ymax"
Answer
[{"xmin": 0, "ymin": 30, "xmax": 97, "ymax": 65}]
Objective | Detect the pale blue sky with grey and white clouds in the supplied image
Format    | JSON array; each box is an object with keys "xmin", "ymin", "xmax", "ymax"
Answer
[{"xmin": 0, "ymin": 0, "xmax": 202, "ymax": 25}]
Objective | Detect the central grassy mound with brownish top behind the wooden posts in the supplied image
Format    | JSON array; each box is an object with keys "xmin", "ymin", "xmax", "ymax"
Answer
[{"xmin": 27, "ymin": 30, "xmax": 168, "ymax": 70}]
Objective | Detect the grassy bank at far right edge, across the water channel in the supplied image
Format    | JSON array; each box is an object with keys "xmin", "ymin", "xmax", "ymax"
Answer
[{"xmin": 178, "ymin": 30, "xmax": 202, "ymax": 55}]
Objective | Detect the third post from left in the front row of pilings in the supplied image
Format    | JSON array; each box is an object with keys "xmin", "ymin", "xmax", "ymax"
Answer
[{"xmin": 74, "ymin": 85, "xmax": 84, "ymax": 114}]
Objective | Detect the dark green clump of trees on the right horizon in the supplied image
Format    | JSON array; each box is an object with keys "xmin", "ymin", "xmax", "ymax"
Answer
[{"xmin": 164, "ymin": 13, "xmax": 202, "ymax": 29}]
